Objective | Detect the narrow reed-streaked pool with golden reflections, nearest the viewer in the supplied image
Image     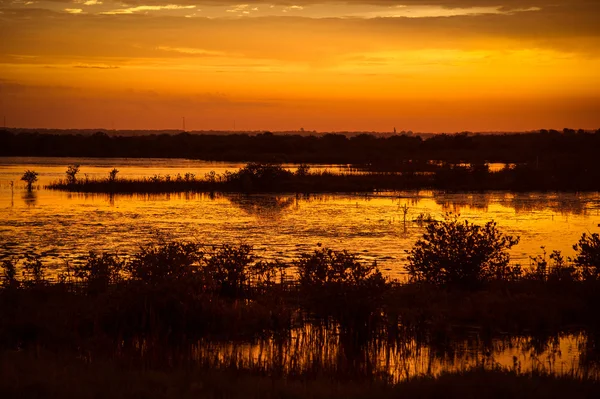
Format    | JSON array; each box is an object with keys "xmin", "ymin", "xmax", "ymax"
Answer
[{"xmin": 123, "ymin": 325, "xmax": 600, "ymax": 382}]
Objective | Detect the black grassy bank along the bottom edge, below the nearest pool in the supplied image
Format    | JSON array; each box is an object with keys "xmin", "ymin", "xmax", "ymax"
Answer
[{"xmin": 0, "ymin": 352, "xmax": 600, "ymax": 399}]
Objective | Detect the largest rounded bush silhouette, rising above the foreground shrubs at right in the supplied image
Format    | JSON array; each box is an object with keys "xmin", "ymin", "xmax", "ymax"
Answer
[{"xmin": 408, "ymin": 216, "xmax": 521, "ymax": 288}]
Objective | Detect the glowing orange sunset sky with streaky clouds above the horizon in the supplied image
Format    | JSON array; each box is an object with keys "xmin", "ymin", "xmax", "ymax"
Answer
[{"xmin": 0, "ymin": 0, "xmax": 600, "ymax": 132}]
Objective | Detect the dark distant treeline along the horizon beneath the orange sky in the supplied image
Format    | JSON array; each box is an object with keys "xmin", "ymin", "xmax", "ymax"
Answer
[{"xmin": 0, "ymin": 129, "xmax": 600, "ymax": 170}]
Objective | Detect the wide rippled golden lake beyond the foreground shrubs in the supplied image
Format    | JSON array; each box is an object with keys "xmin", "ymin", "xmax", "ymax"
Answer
[{"xmin": 0, "ymin": 157, "xmax": 600, "ymax": 279}]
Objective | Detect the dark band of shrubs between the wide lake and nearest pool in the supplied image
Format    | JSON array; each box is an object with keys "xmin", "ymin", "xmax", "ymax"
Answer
[{"xmin": 0, "ymin": 217, "xmax": 600, "ymax": 346}]
